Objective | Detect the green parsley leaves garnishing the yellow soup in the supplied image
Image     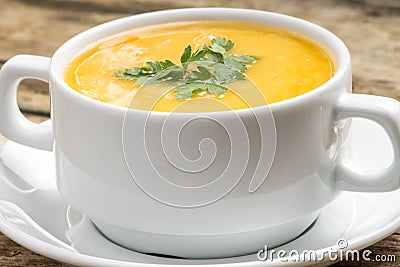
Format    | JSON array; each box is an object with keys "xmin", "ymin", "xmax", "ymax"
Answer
[{"xmin": 114, "ymin": 37, "xmax": 258, "ymax": 99}]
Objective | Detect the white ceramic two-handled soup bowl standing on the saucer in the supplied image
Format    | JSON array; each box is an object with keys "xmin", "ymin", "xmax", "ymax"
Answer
[{"xmin": 0, "ymin": 8, "xmax": 400, "ymax": 258}]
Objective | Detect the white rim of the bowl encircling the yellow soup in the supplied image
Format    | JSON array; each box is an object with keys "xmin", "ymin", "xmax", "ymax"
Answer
[{"xmin": 49, "ymin": 7, "xmax": 351, "ymax": 116}]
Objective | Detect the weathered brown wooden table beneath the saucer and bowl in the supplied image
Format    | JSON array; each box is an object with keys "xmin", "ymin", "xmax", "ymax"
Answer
[{"xmin": 0, "ymin": 0, "xmax": 400, "ymax": 267}]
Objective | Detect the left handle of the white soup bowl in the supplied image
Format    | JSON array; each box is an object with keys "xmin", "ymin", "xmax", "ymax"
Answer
[{"xmin": 0, "ymin": 55, "xmax": 54, "ymax": 151}]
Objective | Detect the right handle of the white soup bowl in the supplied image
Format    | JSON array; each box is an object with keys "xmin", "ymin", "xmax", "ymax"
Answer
[{"xmin": 335, "ymin": 93, "xmax": 400, "ymax": 192}]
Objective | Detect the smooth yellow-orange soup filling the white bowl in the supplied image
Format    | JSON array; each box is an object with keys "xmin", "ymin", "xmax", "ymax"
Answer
[{"xmin": 65, "ymin": 21, "xmax": 334, "ymax": 112}]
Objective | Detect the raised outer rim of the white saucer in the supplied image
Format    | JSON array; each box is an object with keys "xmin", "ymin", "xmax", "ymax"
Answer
[{"xmin": 0, "ymin": 180, "xmax": 400, "ymax": 267}]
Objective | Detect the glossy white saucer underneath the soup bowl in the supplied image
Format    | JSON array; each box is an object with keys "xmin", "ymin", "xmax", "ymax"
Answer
[{"xmin": 0, "ymin": 119, "xmax": 400, "ymax": 267}]
